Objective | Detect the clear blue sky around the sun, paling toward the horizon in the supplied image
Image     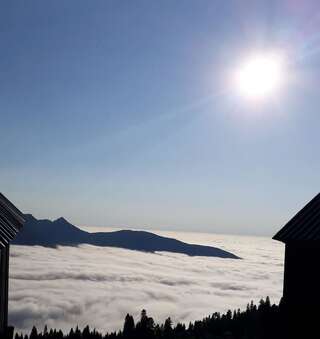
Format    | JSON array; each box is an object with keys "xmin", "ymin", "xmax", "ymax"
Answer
[{"xmin": 0, "ymin": 0, "xmax": 320, "ymax": 235}]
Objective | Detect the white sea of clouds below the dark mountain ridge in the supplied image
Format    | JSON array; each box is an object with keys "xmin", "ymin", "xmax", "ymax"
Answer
[{"xmin": 9, "ymin": 232, "xmax": 284, "ymax": 332}]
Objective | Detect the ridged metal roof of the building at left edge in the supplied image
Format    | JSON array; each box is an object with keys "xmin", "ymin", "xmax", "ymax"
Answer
[{"xmin": 0, "ymin": 193, "xmax": 24, "ymax": 247}]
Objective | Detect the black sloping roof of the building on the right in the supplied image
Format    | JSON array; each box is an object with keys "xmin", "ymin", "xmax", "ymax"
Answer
[{"xmin": 273, "ymin": 193, "xmax": 320, "ymax": 243}]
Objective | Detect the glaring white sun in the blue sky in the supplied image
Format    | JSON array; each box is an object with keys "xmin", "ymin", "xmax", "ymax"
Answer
[{"xmin": 234, "ymin": 54, "xmax": 284, "ymax": 99}]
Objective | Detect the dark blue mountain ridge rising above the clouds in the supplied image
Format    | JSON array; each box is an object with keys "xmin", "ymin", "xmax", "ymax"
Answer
[{"xmin": 13, "ymin": 214, "xmax": 238, "ymax": 259}]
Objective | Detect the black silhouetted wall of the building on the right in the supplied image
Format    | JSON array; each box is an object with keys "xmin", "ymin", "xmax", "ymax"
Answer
[{"xmin": 282, "ymin": 242, "xmax": 320, "ymax": 339}]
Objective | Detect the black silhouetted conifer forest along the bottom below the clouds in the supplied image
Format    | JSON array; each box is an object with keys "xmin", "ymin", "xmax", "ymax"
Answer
[{"xmin": 15, "ymin": 297, "xmax": 283, "ymax": 339}]
